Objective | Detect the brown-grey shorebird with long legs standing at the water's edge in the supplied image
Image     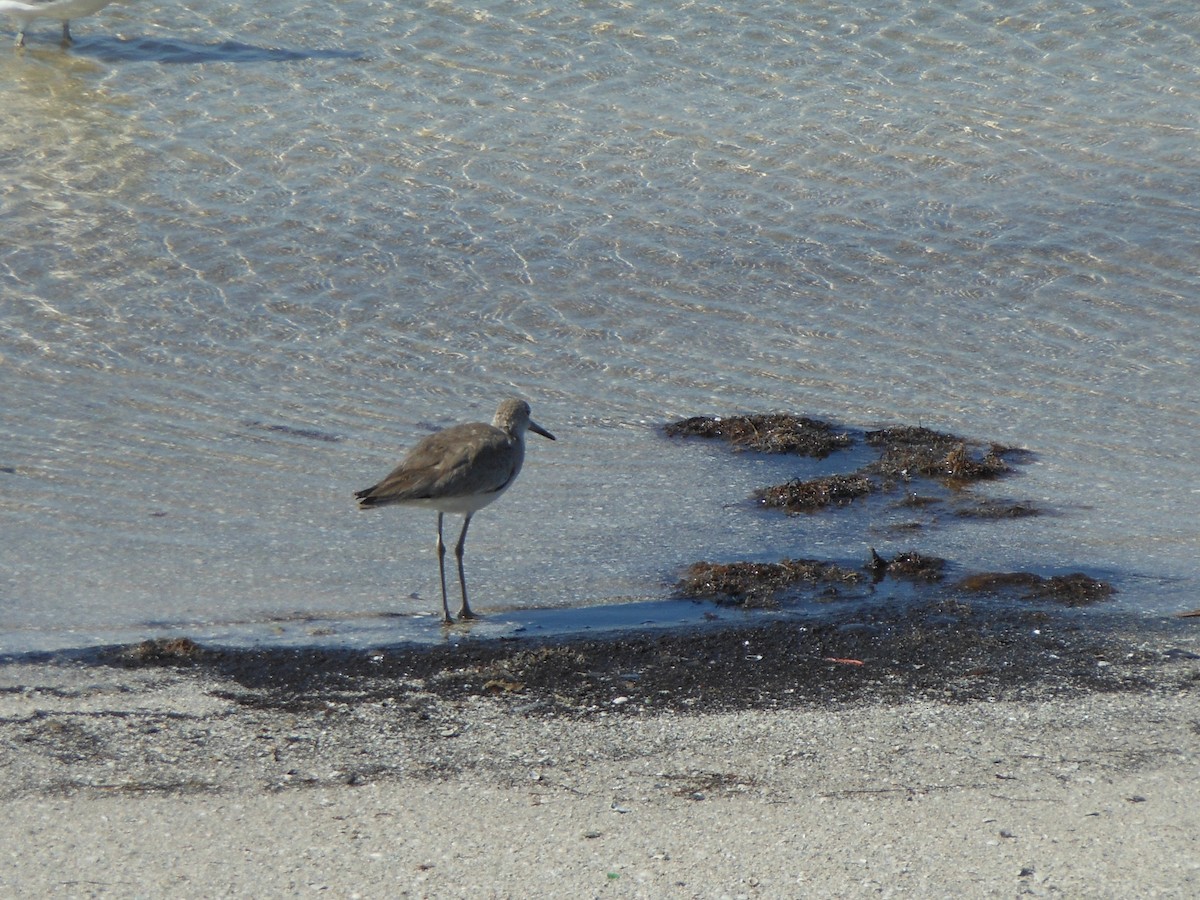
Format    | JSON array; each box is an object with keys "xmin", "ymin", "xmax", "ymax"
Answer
[{"xmin": 354, "ymin": 400, "xmax": 554, "ymax": 625}]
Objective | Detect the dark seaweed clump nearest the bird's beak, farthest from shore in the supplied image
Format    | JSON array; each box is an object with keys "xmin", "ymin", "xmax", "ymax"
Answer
[{"xmin": 664, "ymin": 413, "xmax": 853, "ymax": 460}]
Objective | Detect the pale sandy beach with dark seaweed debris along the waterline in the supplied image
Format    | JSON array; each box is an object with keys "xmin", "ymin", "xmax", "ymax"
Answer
[{"xmin": 0, "ymin": 607, "xmax": 1200, "ymax": 898}]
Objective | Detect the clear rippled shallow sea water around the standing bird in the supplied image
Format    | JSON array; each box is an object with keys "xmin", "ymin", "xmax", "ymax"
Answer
[{"xmin": 0, "ymin": 0, "xmax": 1200, "ymax": 652}]
